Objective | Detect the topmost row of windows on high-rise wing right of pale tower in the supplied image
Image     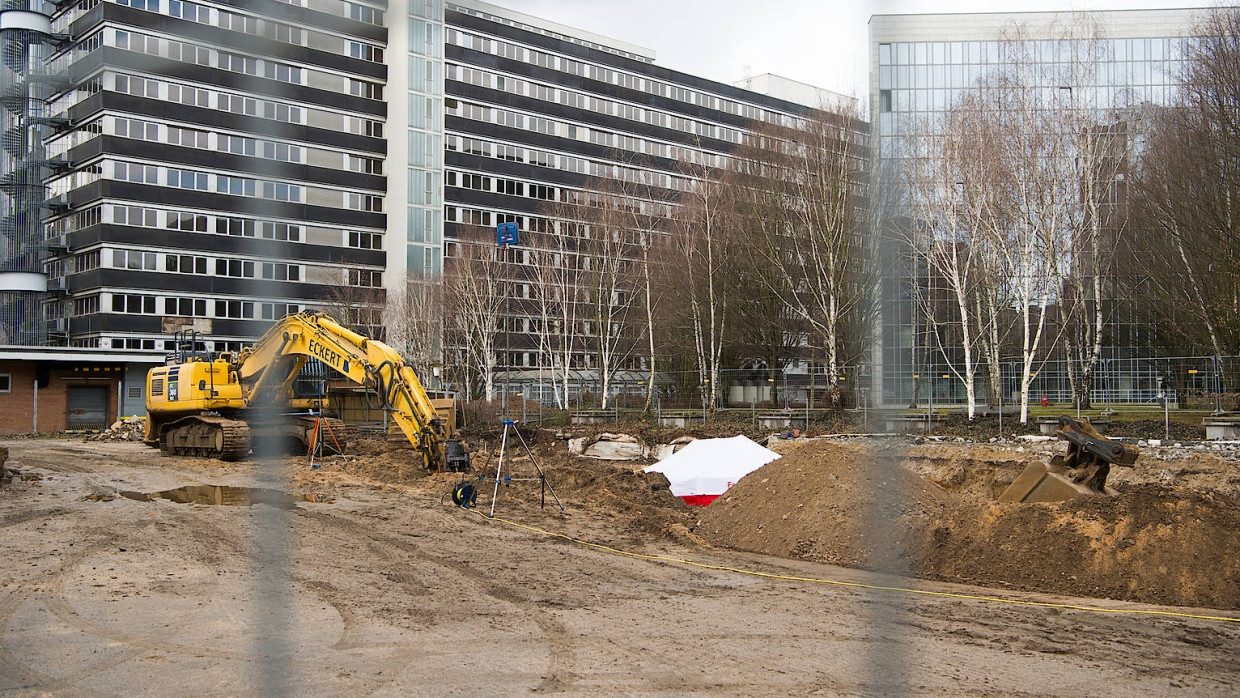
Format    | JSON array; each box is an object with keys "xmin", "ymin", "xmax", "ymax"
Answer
[{"xmin": 445, "ymin": 29, "xmax": 795, "ymax": 126}]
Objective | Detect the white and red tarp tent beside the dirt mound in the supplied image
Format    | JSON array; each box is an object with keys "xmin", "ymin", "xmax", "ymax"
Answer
[{"xmin": 642, "ymin": 435, "xmax": 780, "ymax": 507}]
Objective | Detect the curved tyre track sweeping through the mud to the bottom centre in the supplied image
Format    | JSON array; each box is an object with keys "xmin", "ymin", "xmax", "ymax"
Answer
[{"xmin": 303, "ymin": 510, "xmax": 577, "ymax": 693}]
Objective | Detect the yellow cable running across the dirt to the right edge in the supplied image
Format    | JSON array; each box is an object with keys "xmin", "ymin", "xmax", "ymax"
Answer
[{"xmin": 467, "ymin": 510, "xmax": 1240, "ymax": 622}]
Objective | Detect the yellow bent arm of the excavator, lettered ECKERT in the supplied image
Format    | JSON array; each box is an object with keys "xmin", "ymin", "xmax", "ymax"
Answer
[{"xmin": 237, "ymin": 311, "xmax": 448, "ymax": 470}]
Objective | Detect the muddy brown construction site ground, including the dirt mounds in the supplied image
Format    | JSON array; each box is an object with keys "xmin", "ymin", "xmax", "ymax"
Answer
[{"xmin": 0, "ymin": 434, "xmax": 1240, "ymax": 696}]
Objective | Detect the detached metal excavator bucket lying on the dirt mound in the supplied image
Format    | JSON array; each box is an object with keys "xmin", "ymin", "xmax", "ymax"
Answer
[{"xmin": 999, "ymin": 417, "xmax": 1140, "ymax": 502}]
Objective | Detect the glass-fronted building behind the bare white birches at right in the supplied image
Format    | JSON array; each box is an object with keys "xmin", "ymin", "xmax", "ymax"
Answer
[{"xmin": 869, "ymin": 10, "xmax": 1200, "ymax": 407}]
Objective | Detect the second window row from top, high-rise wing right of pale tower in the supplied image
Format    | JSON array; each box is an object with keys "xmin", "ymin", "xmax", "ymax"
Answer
[{"xmin": 446, "ymin": 63, "xmax": 743, "ymax": 152}]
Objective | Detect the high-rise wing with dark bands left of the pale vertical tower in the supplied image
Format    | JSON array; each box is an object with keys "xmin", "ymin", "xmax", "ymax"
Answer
[{"xmin": 22, "ymin": 0, "xmax": 388, "ymax": 351}]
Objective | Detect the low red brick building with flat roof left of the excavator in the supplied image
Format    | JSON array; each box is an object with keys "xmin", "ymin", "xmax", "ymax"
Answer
[{"xmin": 0, "ymin": 346, "xmax": 164, "ymax": 435}]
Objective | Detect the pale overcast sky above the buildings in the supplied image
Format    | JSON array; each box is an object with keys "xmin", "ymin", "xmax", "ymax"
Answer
[{"xmin": 487, "ymin": 0, "xmax": 1214, "ymax": 97}]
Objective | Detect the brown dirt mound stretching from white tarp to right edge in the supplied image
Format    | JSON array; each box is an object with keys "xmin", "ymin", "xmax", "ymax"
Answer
[{"xmin": 696, "ymin": 443, "xmax": 1240, "ymax": 609}]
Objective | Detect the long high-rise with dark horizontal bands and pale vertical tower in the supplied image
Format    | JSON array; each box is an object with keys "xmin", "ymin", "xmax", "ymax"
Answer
[{"xmin": 0, "ymin": 0, "xmax": 847, "ymax": 366}]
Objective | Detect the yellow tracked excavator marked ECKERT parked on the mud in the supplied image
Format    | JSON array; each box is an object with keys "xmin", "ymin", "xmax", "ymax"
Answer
[{"xmin": 144, "ymin": 311, "xmax": 469, "ymax": 471}]
